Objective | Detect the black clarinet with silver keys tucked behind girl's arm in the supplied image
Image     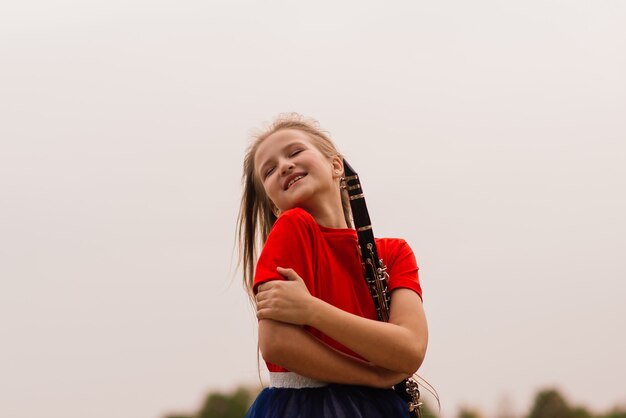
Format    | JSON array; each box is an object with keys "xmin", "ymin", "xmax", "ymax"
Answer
[{"xmin": 341, "ymin": 159, "xmax": 422, "ymax": 418}]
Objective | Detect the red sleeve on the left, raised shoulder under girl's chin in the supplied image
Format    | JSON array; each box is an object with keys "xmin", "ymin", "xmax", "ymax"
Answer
[{"xmin": 253, "ymin": 208, "xmax": 317, "ymax": 294}]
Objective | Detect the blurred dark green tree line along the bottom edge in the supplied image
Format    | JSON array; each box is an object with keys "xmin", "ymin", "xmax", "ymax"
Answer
[{"xmin": 164, "ymin": 387, "xmax": 626, "ymax": 418}]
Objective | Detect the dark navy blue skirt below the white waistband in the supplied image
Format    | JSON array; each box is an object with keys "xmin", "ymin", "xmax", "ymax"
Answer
[{"xmin": 246, "ymin": 384, "xmax": 409, "ymax": 418}]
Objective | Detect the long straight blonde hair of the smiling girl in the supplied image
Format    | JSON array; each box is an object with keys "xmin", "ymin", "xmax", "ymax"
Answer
[{"xmin": 237, "ymin": 113, "xmax": 352, "ymax": 297}]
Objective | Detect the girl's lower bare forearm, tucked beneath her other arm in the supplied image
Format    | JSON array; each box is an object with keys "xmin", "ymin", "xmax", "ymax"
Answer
[{"xmin": 259, "ymin": 319, "xmax": 406, "ymax": 388}]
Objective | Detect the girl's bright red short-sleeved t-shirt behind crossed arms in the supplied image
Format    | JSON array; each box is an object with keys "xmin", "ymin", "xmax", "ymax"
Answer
[{"xmin": 254, "ymin": 208, "xmax": 422, "ymax": 372}]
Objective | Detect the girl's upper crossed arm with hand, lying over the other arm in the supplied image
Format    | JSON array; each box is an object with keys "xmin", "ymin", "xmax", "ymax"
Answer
[{"xmin": 257, "ymin": 268, "xmax": 428, "ymax": 376}]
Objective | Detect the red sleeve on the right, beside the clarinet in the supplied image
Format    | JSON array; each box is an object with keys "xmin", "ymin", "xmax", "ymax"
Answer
[{"xmin": 380, "ymin": 239, "xmax": 422, "ymax": 299}]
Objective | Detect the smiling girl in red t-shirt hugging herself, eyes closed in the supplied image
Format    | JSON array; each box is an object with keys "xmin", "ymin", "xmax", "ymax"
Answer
[{"xmin": 238, "ymin": 114, "xmax": 428, "ymax": 418}]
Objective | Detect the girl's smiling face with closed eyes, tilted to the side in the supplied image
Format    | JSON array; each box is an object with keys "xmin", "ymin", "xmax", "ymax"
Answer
[{"xmin": 254, "ymin": 129, "xmax": 342, "ymax": 213}]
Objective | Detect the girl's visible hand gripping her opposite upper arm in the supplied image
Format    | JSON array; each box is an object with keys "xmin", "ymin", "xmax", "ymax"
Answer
[{"xmin": 256, "ymin": 267, "xmax": 315, "ymax": 325}]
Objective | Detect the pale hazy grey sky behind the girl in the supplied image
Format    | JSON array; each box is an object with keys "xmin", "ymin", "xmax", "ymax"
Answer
[{"xmin": 0, "ymin": 0, "xmax": 626, "ymax": 418}]
